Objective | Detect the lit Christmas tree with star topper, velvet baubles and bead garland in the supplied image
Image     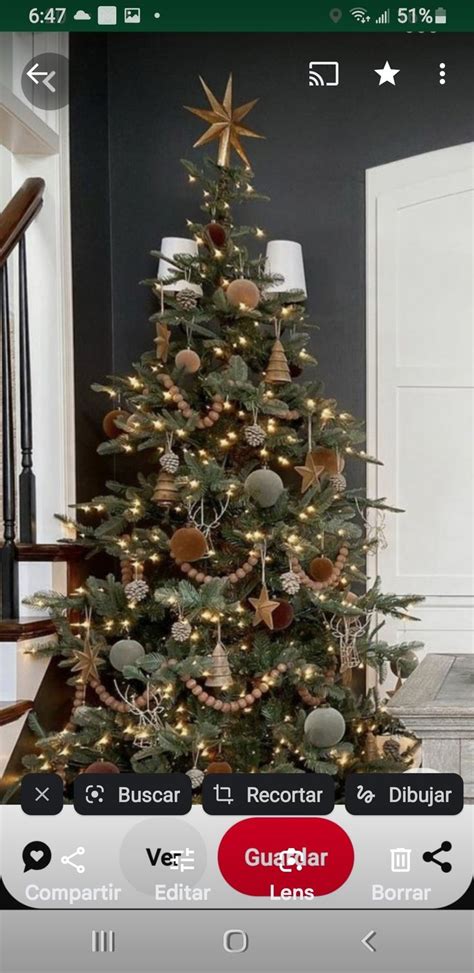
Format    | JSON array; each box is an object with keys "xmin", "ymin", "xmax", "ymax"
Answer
[{"xmin": 17, "ymin": 79, "xmax": 419, "ymax": 794}]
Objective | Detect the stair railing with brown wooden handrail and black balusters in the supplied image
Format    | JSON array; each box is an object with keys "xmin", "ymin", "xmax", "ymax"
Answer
[{"xmin": 0, "ymin": 179, "xmax": 45, "ymax": 619}]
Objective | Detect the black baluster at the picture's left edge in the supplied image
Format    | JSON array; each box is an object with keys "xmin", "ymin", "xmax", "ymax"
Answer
[{"xmin": 0, "ymin": 263, "xmax": 19, "ymax": 618}]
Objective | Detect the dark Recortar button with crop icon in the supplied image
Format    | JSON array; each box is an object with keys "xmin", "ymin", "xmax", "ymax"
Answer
[{"xmin": 202, "ymin": 774, "xmax": 334, "ymax": 817}]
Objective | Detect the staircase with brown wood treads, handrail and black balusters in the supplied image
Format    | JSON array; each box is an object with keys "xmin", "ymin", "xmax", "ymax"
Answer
[{"xmin": 0, "ymin": 178, "xmax": 84, "ymax": 778}]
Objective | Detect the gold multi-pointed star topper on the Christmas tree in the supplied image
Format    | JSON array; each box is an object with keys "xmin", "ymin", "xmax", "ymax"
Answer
[{"xmin": 184, "ymin": 74, "xmax": 265, "ymax": 168}]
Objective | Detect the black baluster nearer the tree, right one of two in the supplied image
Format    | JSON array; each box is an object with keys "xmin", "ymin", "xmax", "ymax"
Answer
[{"xmin": 18, "ymin": 236, "xmax": 36, "ymax": 544}]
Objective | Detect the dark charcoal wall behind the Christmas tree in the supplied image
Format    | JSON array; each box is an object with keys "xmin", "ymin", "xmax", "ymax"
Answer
[{"xmin": 71, "ymin": 33, "xmax": 474, "ymax": 497}]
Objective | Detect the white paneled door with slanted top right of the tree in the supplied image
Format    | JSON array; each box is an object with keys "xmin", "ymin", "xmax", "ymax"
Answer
[{"xmin": 366, "ymin": 144, "xmax": 474, "ymax": 680}]
